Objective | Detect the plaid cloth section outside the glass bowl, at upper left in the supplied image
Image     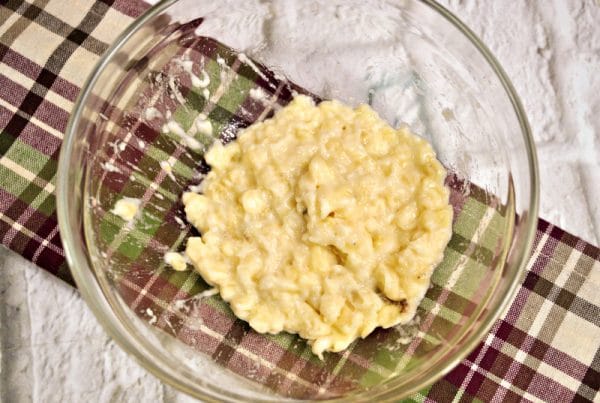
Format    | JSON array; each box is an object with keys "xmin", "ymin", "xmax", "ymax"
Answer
[{"xmin": 0, "ymin": 0, "xmax": 146, "ymax": 283}]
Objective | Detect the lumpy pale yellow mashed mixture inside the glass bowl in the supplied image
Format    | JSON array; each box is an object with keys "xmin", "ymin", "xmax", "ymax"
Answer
[{"xmin": 183, "ymin": 96, "xmax": 452, "ymax": 357}]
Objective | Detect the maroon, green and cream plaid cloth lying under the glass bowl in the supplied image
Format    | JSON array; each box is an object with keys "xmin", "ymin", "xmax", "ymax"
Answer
[{"xmin": 0, "ymin": 0, "xmax": 600, "ymax": 401}]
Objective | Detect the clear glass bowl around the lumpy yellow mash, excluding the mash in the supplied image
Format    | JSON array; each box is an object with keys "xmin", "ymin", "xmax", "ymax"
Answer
[{"xmin": 58, "ymin": 0, "xmax": 538, "ymax": 401}]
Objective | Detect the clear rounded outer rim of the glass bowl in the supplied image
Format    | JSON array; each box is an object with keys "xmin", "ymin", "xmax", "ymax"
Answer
[{"xmin": 56, "ymin": 0, "xmax": 539, "ymax": 401}]
